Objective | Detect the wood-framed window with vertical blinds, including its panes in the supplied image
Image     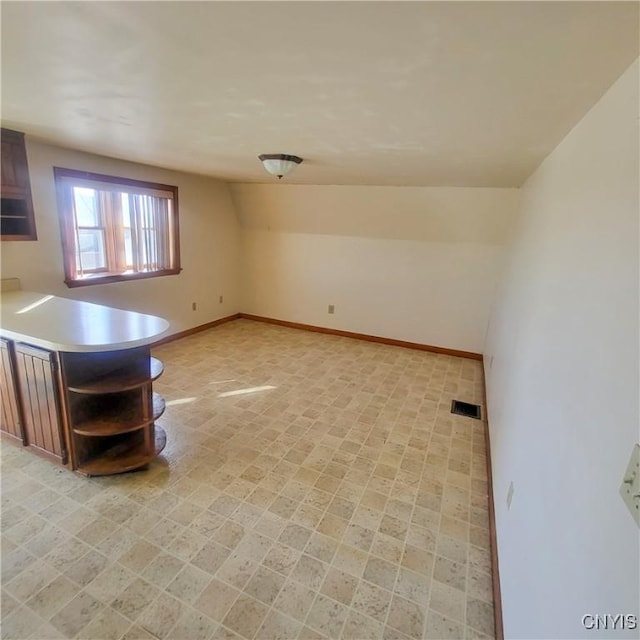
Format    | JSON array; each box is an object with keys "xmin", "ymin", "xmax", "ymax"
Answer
[{"xmin": 53, "ymin": 167, "xmax": 180, "ymax": 287}]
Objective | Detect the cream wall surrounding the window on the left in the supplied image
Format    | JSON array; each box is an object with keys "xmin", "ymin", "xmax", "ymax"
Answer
[{"xmin": 1, "ymin": 138, "xmax": 239, "ymax": 333}]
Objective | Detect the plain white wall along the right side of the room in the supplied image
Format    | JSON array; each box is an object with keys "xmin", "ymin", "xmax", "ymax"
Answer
[{"xmin": 485, "ymin": 62, "xmax": 640, "ymax": 638}]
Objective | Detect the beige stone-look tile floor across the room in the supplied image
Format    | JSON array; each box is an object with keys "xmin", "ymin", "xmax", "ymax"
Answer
[{"xmin": 2, "ymin": 320, "xmax": 494, "ymax": 640}]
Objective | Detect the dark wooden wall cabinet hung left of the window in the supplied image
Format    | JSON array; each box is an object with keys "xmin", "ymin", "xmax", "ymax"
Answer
[{"xmin": 0, "ymin": 129, "xmax": 37, "ymax": 240}]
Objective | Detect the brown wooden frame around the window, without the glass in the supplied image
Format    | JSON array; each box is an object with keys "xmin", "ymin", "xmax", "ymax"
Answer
[{"xmin": 53, "ymin": 167, "xmax": 182, "ymax": 288}]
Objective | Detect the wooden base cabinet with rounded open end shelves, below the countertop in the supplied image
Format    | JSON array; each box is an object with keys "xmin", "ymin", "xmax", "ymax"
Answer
[{"xmin": 0, "ymin": 339, "xmax": 166, "ymax": 476}]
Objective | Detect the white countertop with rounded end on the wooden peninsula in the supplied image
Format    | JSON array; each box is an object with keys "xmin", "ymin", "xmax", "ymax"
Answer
[{"xmin": 0, "ymin": 291, "xmax": 169, "ymax": 352}]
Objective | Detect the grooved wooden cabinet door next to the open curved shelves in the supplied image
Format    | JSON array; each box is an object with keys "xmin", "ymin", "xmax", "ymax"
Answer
[{"xmin": 16, "ymin": 342, "xmax": 67, "ymax": 464}]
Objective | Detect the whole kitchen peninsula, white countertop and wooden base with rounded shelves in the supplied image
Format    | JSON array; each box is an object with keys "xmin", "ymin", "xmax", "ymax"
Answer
[{"xmin": 0, "ymin": 291, "xmax": 169, "ymax": 476}]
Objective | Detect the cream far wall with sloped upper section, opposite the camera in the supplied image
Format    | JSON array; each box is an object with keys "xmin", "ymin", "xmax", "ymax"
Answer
[{"xmin": 231, "ymin": 184, "xmax": 518, "ymax": 352}]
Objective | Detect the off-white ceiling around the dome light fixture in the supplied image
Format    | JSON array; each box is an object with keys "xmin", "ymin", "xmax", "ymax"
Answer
[{"xmin": 1, "ymin": 1, "xmax": 639, "ymax": 186}]
